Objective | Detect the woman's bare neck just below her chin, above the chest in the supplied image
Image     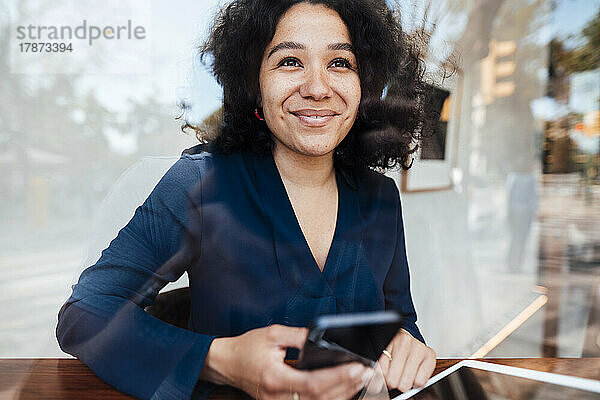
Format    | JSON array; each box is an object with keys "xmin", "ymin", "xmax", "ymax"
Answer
[{"xmin": 273, "ymin": 143, "xmax": 335, "ymax": 189}]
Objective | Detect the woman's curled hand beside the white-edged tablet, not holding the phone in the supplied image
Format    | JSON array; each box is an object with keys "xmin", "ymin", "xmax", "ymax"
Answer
[{"xmin": 378, "ymin": 329, "xmax": 436, "ymax": 392}]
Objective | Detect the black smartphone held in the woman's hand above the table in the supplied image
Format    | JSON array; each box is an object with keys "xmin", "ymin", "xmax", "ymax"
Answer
[{"xmin": 296, "ymin": 311, "xmax": 402, "ymax": 370}]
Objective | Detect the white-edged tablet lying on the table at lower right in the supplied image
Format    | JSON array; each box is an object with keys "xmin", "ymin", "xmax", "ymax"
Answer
[{"xmin": 394, "ymin": 360, "xmax": 600, "ymax": 400}]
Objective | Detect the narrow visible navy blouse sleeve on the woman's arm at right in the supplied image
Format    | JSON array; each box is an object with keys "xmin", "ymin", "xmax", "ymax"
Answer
[{"xmin": 383, "ymin": 183, "xmax": 425, "ymax": 343}]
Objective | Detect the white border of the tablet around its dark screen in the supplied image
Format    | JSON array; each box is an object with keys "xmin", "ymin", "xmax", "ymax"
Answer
[{"xmin": 393, "ymin": 360, "xmax": 600, "ymax": 400}]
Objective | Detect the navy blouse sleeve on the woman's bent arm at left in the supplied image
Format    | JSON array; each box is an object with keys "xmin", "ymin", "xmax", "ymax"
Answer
[{"xmin": 56, "ymin": 157, "xmax": 214, "ymax": 399}]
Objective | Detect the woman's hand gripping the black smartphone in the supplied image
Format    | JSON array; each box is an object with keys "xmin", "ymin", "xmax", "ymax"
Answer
[{"xmin": 200, "ymin": 325, "xmax": 372, "ymax": 400}]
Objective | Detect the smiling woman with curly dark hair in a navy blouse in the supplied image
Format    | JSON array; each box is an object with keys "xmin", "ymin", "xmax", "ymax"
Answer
[{"xmin": 57, "ymin": 0, "xmax": 435, "ymax": 399}]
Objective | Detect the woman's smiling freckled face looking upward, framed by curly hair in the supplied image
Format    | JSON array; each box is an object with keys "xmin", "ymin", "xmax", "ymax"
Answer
[{"xmin": 259, "ymin": 3, "xmax": 361, "ymax": 156}]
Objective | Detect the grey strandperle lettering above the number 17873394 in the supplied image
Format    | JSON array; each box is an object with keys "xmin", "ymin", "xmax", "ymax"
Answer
[{"xmin": 16, "ymin": 19, "xmax": 146, "ymax": 46}]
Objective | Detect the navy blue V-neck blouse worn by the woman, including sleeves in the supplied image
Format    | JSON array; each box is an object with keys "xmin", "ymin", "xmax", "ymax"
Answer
[{"xmin": 57, "ymin": 151, "xmax": 423, "ymax": 399}]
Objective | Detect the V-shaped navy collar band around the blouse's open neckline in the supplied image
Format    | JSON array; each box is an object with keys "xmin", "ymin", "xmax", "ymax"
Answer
[{"xmin": 247, "ymin": 153, "xmax": 362, "ymax": 297}]
